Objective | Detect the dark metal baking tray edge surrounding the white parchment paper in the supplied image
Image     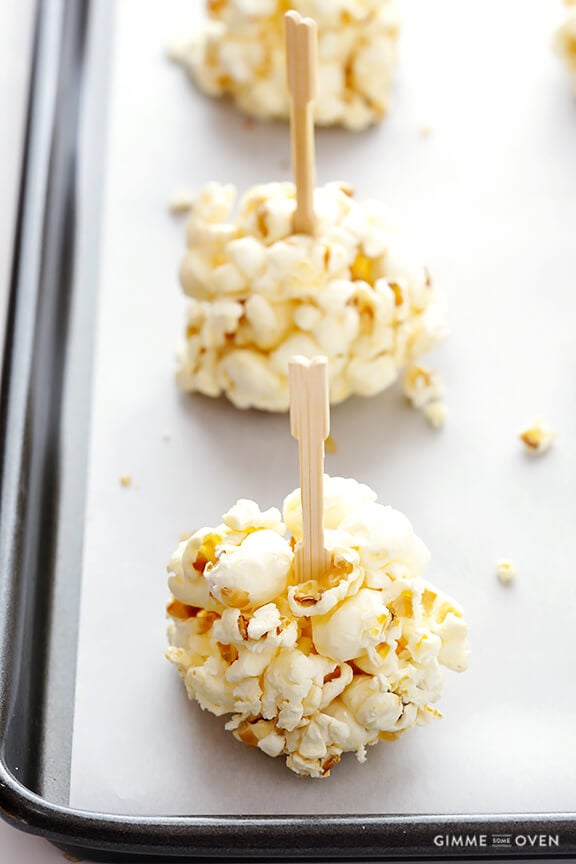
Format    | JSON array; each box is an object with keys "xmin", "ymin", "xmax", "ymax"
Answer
[{"xmin": 0, "ymin": 0, "xmax": 576, "ymax": 862}]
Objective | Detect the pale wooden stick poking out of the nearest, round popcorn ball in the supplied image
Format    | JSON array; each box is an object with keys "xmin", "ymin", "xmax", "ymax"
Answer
[{"xmin": 289, "ymin": 357, "xmax": 330, "ymax": 582}]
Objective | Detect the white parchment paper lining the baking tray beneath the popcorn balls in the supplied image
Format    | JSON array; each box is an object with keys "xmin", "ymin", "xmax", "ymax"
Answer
[{"xmin": 70, "ymin": 0, "xmax": 576, "ymax": 815}]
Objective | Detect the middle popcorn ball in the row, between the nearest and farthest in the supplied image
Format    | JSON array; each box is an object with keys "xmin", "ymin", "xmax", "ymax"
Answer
[{"xmin": 177, "ymin": 183, "xmax": 447, "ymax": 411}]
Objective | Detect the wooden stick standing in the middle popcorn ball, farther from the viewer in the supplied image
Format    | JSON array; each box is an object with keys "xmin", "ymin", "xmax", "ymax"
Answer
[{"xmin": 284, "ymin": 11, "xmax": 318, "ymax": 234}]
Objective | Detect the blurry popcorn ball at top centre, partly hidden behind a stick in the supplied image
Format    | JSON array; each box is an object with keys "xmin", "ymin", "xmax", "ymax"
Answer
[{"xmin": 170, "ymin": 0, "xmax": 398, "ymax": 129}]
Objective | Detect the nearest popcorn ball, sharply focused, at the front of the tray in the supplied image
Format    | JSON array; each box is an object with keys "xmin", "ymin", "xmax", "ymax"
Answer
[{"xmin": 167, "ymin": 477, "xmax": 468, "ymax": 777}]
